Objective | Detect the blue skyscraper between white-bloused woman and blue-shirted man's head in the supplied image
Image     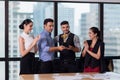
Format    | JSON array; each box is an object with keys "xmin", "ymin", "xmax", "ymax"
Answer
[{"xmin": 33, "ymin": 2, "xmax": 53, "ymax": 35}]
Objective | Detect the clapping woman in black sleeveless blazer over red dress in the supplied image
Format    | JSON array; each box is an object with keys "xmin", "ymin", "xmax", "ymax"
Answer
[{"xmin": 82, "ymin": 27, "xmax": 104, "ymax": 72}]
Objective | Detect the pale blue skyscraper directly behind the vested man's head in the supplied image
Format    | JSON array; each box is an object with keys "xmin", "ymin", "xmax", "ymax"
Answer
[{"xmin": 58, "ymin": 3, "xmax": 75, "ymax": 34}]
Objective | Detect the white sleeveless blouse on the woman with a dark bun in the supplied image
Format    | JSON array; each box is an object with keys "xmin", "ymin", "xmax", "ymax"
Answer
[{"xmin": 20, "ymin": 32, "xmax": 35, "ymax": 53}]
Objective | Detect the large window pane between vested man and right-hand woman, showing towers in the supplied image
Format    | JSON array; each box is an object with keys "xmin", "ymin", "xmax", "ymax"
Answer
[{"xmin": 58, "ymin": 3, "xmax": 99, "ymax": 57}]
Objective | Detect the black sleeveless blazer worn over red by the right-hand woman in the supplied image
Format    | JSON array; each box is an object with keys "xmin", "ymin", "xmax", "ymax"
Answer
[{"xmin": 84, "ymin": 39, "xmax": 104, "ymax": 72}]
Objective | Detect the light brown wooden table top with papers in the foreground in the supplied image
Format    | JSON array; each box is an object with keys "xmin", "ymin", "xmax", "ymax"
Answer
[{"xmin": 20, "ymin": 73, "xmax": 102, "ymax": 80}]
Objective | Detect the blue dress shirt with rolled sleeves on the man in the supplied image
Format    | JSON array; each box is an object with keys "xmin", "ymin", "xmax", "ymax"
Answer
[{"xmin": 38, "ymin": 30, "xmax": 54, "ymax": 61}]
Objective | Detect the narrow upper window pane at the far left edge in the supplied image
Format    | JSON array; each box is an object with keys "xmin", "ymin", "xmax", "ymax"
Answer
[{"xmin": 0, "ymin": 1, "xmax": 5, "ymax": 57}]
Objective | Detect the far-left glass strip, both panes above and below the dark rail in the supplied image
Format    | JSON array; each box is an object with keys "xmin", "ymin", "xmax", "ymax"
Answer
[{"xmin": 0, "ymin": 1, "xmax": 5, "ymax": 80}]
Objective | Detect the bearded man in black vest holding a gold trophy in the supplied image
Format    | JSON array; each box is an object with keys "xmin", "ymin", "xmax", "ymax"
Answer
[{"xmin": 55, "ymin": 21, "xmax": 80, "ymax": 73}]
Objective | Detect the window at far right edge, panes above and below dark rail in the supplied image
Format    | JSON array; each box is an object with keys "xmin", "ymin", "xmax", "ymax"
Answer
[{"xmin": 104, "ymin": 4, "xmax": 120, "ymax": 72}]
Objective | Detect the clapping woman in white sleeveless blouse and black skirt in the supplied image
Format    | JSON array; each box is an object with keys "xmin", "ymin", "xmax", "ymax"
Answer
[{"xmin": 19, "ymin": 19, "xmax": 39, "ymax": 74}]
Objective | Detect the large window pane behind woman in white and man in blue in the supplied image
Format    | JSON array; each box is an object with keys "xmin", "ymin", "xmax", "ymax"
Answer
[{"xmin": 9, "ymin": 1, "xmax": 54, "ymax": 57}]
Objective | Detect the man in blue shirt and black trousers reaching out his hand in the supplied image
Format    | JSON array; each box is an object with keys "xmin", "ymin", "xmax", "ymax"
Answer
[{"xmin": 38, "ymin": 18, "xmax": 64, "ymax": 73}]
